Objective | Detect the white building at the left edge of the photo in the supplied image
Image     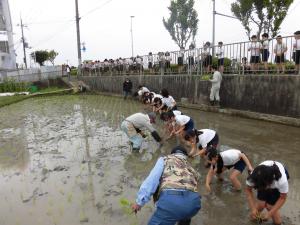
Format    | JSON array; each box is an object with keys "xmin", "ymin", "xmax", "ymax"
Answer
[{"xmin": 0, "ymin": 0, "xmax": 16, "ymax": 71}]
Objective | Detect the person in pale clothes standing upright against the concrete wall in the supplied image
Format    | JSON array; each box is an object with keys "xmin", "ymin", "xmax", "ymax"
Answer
[{"xmin": 209, "ymin": 66, "xmax": 222, "ymax": 106}]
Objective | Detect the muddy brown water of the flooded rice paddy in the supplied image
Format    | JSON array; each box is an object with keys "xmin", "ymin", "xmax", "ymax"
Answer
[{"xmin": 0, "ymin": 96, "xmax": 300, "ymax": 225}]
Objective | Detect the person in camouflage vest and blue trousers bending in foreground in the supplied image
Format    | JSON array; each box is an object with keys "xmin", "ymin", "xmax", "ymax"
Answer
[{"xmin": 132, "ymin": 146, "xmax": 201, "ymax": 225}]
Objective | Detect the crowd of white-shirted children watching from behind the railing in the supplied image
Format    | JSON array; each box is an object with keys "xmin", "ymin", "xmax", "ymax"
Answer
[{"xmin": 82, "ymin": 31, "xmax": 300, "ymax": 75}]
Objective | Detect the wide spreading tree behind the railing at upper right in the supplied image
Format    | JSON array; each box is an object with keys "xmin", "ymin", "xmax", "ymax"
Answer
[{"xmin": 231, "ymin": 0, "xmax": 293, "ymax": 39}]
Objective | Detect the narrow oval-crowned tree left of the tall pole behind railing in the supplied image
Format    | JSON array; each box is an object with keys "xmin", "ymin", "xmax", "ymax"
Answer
[{"xmin": 163, "ymin": 0, "xmax": 199, "ymax": 48}]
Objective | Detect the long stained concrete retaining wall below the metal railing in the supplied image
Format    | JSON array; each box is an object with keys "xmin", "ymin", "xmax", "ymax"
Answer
[{"xmin": 80, "ymin": 75, "xmax": 300, "ymax": 118}]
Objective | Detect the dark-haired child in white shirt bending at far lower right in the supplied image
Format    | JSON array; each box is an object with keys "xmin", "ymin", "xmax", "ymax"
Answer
[{"xmin": 246, "ymin": 160, "xmax": 289, "ymax": 225}]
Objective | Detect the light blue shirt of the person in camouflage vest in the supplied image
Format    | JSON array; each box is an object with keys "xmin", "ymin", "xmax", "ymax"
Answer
[{"xmin": 136, "ymin": 153, "xmax": 186, "ymax": 206}]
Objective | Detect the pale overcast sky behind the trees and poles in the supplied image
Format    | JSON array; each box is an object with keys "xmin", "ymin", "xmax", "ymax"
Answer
[{"xmin": 9, "ymin": 0, "xmax": 300, "ymax": 65}]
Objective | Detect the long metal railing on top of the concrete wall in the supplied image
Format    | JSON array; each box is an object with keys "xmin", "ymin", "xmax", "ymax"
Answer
[{"xmin": 82, "ymin": 36, "xmax": 300, "ymax": 76}]
